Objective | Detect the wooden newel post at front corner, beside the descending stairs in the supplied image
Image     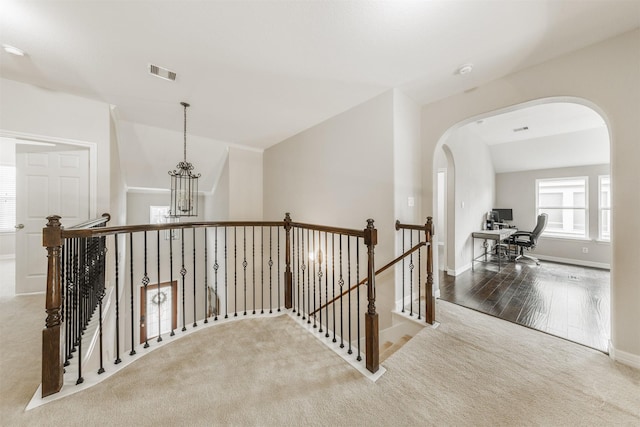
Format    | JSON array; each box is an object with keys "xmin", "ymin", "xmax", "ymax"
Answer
[{"xmin": 364, "ymin": 219, "xmax": 380, "ymax": 372}]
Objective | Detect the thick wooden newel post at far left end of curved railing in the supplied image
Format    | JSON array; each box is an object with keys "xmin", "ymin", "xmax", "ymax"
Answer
[{"xmin": 42, "ymin": 215, "xmax": 63, "ymax": 397}]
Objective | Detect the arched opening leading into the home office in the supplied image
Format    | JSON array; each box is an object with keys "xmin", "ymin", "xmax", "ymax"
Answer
[{"xmin": 433, "ymin": 97, "xmax": 611, "ymax": 352}]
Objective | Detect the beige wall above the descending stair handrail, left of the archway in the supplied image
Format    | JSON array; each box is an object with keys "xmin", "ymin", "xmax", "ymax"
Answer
[{"xmin": 264, "ymin": 91, "xmax": 396, "ymax": 328}]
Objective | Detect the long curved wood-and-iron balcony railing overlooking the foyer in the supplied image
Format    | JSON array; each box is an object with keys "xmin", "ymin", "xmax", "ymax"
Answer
[{"xmin": 42, "ymin": 214, "xmax": 379, "ymax": 397}]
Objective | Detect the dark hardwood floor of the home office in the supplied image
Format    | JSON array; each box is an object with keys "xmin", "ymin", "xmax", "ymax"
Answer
[{"xmin": 440, "ymin": 261, "xmax": 610, "ymax": 353}]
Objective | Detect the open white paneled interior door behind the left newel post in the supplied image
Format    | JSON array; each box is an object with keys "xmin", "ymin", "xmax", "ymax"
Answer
[{"xmin": 16, "ymin": 150, "xmax": 89, "ymax": 294}]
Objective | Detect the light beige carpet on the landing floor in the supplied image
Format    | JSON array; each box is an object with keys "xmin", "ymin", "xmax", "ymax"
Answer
[{"xmin": 0, "ymin": 296, "xmax": 640, "ymax": 426}]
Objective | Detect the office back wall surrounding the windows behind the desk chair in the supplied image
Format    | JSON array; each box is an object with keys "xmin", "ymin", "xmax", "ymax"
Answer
[{"xmin": 495, "ymin": 165, "xmax": 611, "ymax": 268}]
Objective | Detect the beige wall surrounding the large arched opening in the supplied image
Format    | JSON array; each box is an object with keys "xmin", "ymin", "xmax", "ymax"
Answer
[{"xmin": 422, "ymin": 30, "xmax": 640, "ymax": 367}]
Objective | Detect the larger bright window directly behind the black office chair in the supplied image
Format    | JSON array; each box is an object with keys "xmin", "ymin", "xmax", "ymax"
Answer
[{"xmin": 536, "ymin": 177, "xmax": 588, "ymax": 238}]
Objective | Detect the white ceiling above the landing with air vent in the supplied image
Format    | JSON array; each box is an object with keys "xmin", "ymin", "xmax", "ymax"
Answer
[{"xmin": 0, "ymin": 0, "xmax": 640, "ymax": 149}]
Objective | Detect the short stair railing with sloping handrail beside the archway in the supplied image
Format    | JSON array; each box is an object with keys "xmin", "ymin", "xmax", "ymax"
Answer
[{"xmin": 310, "ymin": 217, "xmax": 435, "ymax": 325}]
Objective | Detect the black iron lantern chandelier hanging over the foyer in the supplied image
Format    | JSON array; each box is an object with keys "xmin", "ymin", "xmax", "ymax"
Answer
[{"xmin": 169, "ymin": 102, "xmax": 200, "ymax": 218}]
